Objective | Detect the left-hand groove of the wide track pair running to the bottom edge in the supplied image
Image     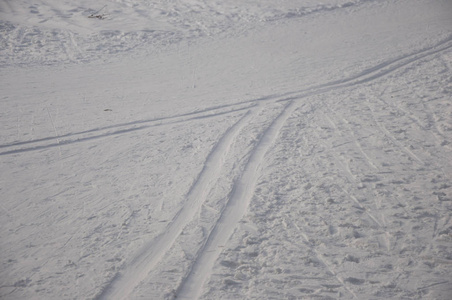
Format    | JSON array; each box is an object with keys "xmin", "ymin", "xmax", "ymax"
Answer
[{"xmin": 96, "ymin": 110, "xmax": 253, "ymax": 300}]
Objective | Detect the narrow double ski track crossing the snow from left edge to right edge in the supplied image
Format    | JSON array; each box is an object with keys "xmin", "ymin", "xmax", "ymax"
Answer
[{"xmin": 0, "ymin": 36, "xmax": 452, "ymax": 156}]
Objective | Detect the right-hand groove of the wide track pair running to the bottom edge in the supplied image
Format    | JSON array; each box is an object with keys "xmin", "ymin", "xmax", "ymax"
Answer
[{"xmin": 176, "ymin": 101, "xmax": 297, "ymax": 299}]
